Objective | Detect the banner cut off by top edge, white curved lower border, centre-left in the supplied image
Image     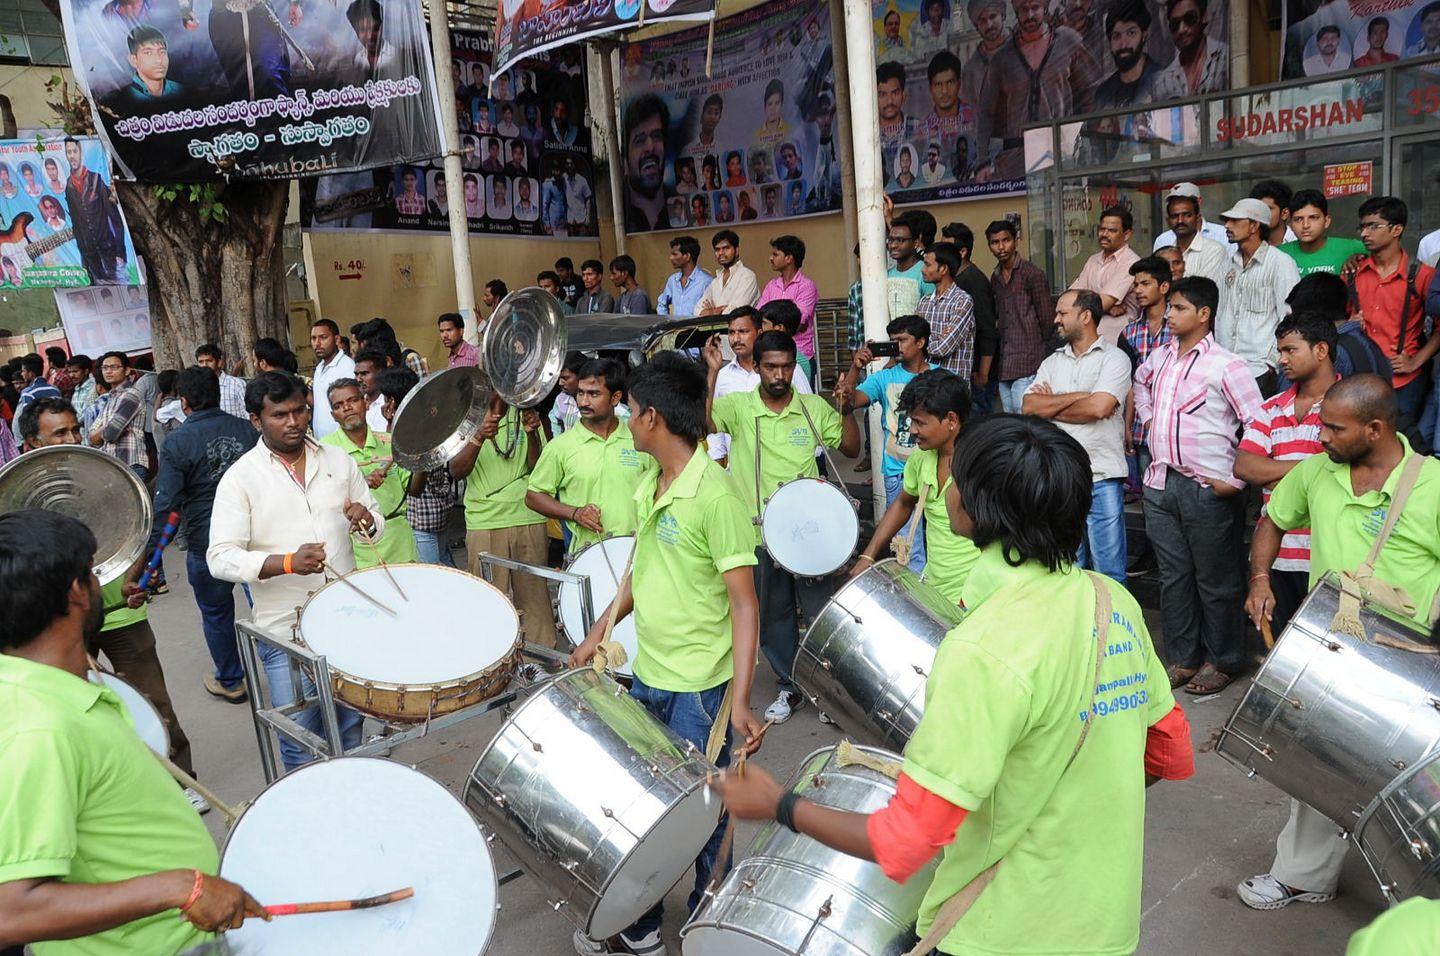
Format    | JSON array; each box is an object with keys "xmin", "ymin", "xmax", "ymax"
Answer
[{"xmin": 492, "ymin": 0, "xmax": 716, "ymax": 75}]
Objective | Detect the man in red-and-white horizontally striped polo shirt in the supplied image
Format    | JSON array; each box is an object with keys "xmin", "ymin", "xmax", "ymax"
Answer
[{"xmin": 1236, "ymin": 312, "xmax": 1341, "ymax": 633}]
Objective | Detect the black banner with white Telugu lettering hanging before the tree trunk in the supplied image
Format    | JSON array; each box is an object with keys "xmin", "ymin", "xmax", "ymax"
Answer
[{"xmin": 60, "ymin": 0, "xmax": 441, "ymax": 183}]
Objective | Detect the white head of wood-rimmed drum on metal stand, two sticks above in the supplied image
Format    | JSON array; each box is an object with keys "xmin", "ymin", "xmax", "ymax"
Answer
[{"xmin": 300, "ymin": 564, "xmax": 520, "ymax": 684}]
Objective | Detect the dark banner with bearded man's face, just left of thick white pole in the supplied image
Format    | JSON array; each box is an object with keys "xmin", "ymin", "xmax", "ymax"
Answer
[{"xmin": 621, "ymin": 0, "xmax": 840, "ymax": 232}]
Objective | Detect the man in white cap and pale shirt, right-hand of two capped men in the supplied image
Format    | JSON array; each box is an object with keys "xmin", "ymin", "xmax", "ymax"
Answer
[{"xmin": 1215, "ymin": 199, "xmax": 1300, "ymax": 397}]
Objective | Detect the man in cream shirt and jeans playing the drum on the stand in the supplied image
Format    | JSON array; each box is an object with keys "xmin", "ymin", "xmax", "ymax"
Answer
[{"xmin": 204, "ymin": 368, "xmax": 384, "ymax": 770}]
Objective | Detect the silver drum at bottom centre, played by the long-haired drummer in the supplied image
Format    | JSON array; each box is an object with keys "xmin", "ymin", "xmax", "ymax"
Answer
[{"xmin": 680, "ymin": 747, "xmax": 939, "ymax": 956}]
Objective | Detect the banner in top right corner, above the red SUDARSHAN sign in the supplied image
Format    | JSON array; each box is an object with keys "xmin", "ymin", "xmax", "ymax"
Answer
[{"xmin": 1280, "ymin": 0, "xmax": 1440, "ymax": 79}]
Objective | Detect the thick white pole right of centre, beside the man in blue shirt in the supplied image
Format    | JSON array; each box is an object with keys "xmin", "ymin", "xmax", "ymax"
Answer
[{"xmin": 832, "ymin": 0, "xmax": 890, "ymax": 521}]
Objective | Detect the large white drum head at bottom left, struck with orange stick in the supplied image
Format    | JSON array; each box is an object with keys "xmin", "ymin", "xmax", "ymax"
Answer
[{"xmin": 220, "ymin": 757, "xmax": 498, "ymax": 956}]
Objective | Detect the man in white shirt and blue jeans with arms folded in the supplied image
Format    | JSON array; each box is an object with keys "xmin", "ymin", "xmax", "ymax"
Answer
[{"xmin": 1021, "ymin": 289, "xmax": 1130, "ymax": 585}]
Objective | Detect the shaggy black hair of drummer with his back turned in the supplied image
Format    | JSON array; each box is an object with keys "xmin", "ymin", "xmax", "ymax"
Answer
[{"xmin": 950, "ymin": 415, "xmax": 1092, "ymax": 572}]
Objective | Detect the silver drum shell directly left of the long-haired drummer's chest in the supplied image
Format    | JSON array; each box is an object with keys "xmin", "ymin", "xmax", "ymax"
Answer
[{"xmin": 793, "ymin": 559, "xmax": 962, "ymax": 752}]
